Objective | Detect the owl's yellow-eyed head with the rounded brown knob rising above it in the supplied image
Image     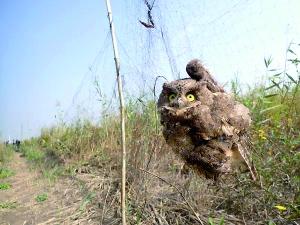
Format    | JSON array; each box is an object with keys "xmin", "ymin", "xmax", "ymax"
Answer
[{"xmin": 157, "ymin": 59, "xmax": 222, "ymax": 122}]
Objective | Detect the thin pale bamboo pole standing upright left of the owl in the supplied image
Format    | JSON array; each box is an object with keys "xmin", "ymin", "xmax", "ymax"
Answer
[{"xmin": 106, "ymin": 0, "xmax": 126, "ymax": 225}]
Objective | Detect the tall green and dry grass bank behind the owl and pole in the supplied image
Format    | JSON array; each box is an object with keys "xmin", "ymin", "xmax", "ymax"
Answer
[{"xmin": 12, "ymin": 45, "xmax": 300, "ymax": 224}]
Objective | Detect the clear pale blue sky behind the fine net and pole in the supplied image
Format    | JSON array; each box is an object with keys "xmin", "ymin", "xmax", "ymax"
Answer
[{"xmin": 0, "ymin": 0, "xmax": 300, "ymax": 140}]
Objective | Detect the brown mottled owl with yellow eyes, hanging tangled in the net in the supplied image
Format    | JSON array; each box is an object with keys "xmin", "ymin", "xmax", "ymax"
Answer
[{"xmin": 157, "ymin": 59, "xmax": 256, "ymax": 180}]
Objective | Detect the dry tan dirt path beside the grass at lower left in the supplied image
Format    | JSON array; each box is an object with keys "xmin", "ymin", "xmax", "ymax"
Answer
[{"xmin": 0, "ymin": 153, "xmax": 98, "ymax": 225}]
